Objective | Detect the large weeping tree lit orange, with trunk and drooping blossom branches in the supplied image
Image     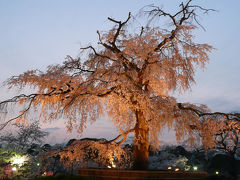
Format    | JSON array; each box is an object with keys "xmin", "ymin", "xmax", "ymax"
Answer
[{"xmin": 0, "ymin": 0, "xmax": 239, "ymax": 169}]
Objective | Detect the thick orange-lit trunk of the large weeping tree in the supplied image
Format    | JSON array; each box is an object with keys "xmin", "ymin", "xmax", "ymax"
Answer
[{"xmin": 133, "ymin": 111, "xmax": 149, "ymax": 170}]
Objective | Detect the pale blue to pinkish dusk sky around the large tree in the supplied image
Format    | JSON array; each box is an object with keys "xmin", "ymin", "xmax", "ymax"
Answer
[{"xmin": 0, "ymin": 0, "xmax": 240, "ymax": 145}]
